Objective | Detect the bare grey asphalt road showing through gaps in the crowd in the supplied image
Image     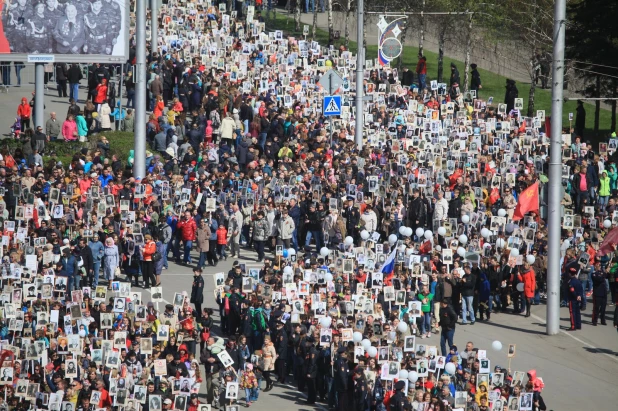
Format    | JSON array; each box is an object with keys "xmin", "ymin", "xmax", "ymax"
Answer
[{"xmin": 152, "ymin": 245, "xmax": 618, "ymax": 410}]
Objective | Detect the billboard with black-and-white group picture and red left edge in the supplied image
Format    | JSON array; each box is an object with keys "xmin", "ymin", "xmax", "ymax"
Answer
[{"xmin": 0, "ymin": 0, "xmax": 130, "ymax": 63}]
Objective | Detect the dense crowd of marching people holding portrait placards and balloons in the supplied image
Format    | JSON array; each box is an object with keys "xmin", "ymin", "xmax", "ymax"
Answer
[{"xmin": 0, "ymin": 0, "xmax": 618, "ymax": 411}]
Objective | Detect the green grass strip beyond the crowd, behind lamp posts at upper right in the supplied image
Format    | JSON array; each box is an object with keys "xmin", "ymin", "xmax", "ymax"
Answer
[{"xmin": 269, "ymin": 14, "xmax": 611, "ymax": 141}]
